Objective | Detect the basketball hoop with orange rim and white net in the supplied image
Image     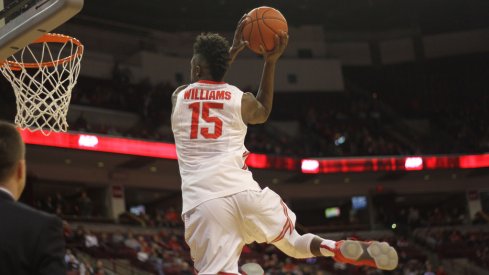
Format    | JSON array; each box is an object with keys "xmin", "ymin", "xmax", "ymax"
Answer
[{"xmin": 0, "ymin": 33, "xmax": 83, "ymax": 135}]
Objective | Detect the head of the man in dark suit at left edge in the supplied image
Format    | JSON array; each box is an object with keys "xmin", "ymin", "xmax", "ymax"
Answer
[{"xmin": 0, "ymin": 120, "xmax": 25, "ymax": 185}]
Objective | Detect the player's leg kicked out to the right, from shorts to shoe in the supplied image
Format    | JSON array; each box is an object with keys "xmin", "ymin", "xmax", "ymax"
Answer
[{"xmin": 240, "ymin": 188, "xmax": 398, "ymax": 270}]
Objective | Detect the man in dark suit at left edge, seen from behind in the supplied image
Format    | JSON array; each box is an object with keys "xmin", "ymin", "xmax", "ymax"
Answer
[{"xmin": 0, "ymin": 121, "xmax": 66, "ymax": 275}]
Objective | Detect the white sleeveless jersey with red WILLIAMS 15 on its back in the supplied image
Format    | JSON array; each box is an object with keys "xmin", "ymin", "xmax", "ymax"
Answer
[{"xmin": 171, "ymin": 81, "xmax": 261, "ymax": 213}]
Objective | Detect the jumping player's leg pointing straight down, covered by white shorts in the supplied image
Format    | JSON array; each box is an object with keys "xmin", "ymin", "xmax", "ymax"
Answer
[{"xmin": 184, "ymin": 197, "xmax": 244, "ymax": 274}]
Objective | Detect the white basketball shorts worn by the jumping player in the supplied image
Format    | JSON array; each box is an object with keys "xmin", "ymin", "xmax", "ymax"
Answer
[{"xmin": 183, "ymin": 188, "xmax": 296, "ymax": 274}]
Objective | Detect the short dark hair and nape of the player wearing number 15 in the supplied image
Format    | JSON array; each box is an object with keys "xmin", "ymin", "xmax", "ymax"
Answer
[{"xmin": 194, "ymin": 33, "xmax": 230, "ymax": 81}]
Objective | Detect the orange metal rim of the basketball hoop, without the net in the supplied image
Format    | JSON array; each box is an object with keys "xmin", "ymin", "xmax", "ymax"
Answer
[{"xmin": 0, "ymin": 33, "xmax": 83, "ymax": 71}]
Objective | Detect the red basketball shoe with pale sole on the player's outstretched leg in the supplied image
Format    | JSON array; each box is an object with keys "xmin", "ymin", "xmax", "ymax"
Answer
[{"xmin": 321, "ymin": 240, "xmax": 398, "ymax": 270}]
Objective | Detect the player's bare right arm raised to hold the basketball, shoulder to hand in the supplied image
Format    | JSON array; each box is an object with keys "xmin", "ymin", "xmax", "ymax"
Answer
[{"xmin": 241, "ymin": 32, "xmax": 289, "ymax": 124}]
